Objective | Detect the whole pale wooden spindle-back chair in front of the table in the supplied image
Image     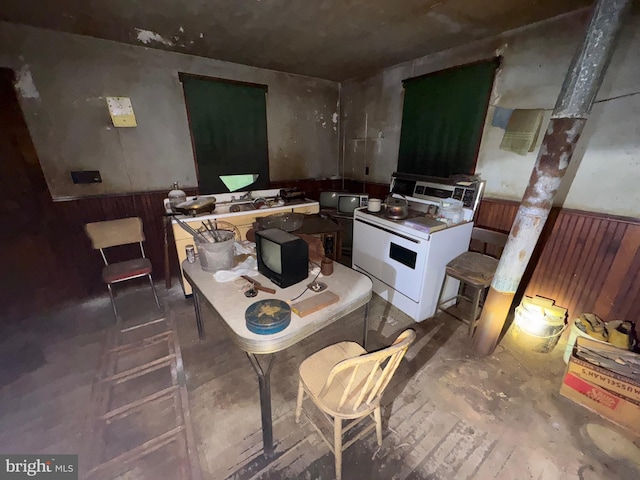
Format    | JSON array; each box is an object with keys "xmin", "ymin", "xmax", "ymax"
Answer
[{"xmin": 296, "ymin": 329, "xmax": 416, "ymax": 480}]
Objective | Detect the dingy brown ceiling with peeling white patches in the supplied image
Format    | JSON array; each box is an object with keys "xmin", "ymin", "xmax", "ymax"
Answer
[{"xmin": 0, "ymin": 0, "xmax": 592, "ymax": 81}]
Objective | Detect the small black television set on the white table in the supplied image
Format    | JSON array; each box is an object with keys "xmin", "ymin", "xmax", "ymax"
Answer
[{"xmin": 256, "ymin": 228, "xmax": 309, "ymax": 288}]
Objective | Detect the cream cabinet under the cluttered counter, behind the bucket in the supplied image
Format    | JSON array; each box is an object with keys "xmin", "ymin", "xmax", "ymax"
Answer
[{"xmin": 171, "ymin": 200, "xmax": 320, "ymax": 295}]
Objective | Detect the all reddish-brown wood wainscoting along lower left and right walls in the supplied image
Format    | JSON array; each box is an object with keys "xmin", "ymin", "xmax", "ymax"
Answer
[{"xmin": 2, "ymin": 179, "xmax": 640, "ymax": 321}]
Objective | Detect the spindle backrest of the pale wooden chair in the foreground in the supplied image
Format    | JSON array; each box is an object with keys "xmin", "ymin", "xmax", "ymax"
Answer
[{"xmin": 320, "ymin": 329, "xmax": 416, "ymax": 412}]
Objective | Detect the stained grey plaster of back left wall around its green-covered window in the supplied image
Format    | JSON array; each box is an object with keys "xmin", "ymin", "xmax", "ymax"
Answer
[{"xmin": 0, "ymin": 22, "xmax": 339, "ymax": 200}]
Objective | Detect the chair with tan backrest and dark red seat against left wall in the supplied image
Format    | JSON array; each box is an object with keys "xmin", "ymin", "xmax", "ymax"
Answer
[{"xmin": 85, "ymin": 217, "xmax": 160, "ymax": 321}]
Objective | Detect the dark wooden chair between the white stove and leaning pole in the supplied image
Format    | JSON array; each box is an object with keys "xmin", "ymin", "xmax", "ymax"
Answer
[{"xmin": 436, "ymin": 227, "xmax": 509, "ymax": 337}]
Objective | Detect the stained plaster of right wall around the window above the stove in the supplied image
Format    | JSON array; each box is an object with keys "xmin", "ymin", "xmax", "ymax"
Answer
[{"xmin": 341, "ymin": 10, "xmax": 640, "ymax": 217}]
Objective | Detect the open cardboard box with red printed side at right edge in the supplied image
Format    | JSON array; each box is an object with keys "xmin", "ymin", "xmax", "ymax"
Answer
[{"xmin": 560, "ymin": 337, "xmax": 640, "ymax": 434}]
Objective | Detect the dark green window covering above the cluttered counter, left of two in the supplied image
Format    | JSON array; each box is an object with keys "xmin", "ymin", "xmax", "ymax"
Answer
[{"xmin": 181, "ymin": 75, "xmax": 269, "ymax": 194}]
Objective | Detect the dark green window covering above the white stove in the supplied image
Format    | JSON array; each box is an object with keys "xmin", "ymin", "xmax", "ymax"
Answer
[{"xmin": 398, "ymin": 59, "xmax": 498, "ymax": 177}]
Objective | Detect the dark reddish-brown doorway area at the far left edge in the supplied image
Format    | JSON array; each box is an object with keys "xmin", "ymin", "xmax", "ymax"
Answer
[{"xmin": 0, "ymin": 68, "xmax": 66, "ymax": 320}]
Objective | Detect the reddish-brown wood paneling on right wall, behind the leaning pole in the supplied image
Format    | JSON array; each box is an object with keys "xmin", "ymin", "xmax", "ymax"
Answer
[{"xmin": 476, "ymin": 199, "xmax": 640, "ymax": 322}]
